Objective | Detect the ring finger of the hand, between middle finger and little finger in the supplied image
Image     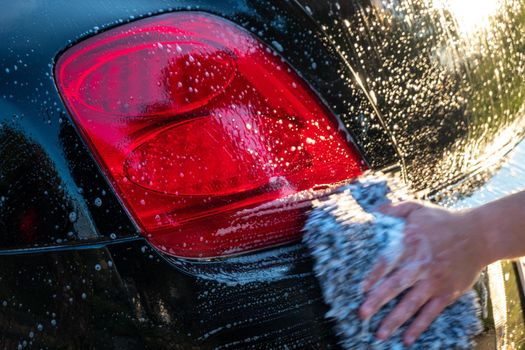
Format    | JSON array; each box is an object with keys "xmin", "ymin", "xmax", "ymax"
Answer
[{"xmin": 377, "ymin": 284, "xmax": 431, "ymax": 340}]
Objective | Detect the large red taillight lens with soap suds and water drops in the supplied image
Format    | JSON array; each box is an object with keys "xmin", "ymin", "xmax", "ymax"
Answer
[{"xmin": 56, "ymin": 12, "xmax": 363, "ymax": 257}]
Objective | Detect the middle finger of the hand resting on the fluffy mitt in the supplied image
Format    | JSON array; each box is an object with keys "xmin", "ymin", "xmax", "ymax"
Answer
[{"xmin": 359, "ymin": 268, "xmax": 418, "ymax": 319}]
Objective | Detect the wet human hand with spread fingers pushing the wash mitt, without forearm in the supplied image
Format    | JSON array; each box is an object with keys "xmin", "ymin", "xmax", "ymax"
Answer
[{"xmin": 359, "ymin": 202, "xmax": 491, "ymax": 345}]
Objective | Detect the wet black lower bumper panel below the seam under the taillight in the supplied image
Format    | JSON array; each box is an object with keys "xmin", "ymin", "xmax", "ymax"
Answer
[{"xmin": 0, "ymin": 242, "xmax": 335, "ymax": 349}]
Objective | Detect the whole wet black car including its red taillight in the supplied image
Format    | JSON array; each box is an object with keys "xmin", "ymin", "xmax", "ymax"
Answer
[{"xmin": 0, "ymin": 0, "xmax": 525, "ymax": 349}]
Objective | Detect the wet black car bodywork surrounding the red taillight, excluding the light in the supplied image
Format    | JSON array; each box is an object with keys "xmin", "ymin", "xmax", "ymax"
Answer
[{"xmin": 0, "ymin": 0, "xmax": 525, "ymax": 349}]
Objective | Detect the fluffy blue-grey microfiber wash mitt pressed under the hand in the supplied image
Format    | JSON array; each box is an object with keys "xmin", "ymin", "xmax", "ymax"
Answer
[{"xmin": 304, "ymin": 174, "xmax": 482, "ymax": 349}]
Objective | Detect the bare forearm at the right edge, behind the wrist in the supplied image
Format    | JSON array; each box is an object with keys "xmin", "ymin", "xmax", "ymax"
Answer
[{"xmin": 468, "ymin": 191, "xmax": 525, "ymax": 264}]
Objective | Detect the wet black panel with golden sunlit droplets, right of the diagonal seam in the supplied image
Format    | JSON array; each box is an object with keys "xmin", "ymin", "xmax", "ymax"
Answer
[{"xmin": 298, "ymin": 0, "xmax": 525, "ymax": 189}]
